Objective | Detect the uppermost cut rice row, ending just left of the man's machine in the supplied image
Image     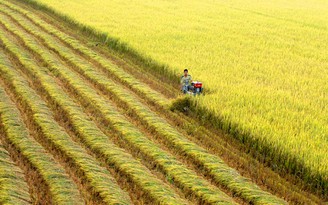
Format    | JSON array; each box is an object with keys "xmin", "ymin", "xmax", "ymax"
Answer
[{"xmin": 1, "ymin": 1, "xmax": 169, "ymax": 106}]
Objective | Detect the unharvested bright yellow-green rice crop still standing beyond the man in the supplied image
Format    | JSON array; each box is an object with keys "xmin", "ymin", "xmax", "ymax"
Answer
[{"xmin": 32, "ymin": 0, "xmax": 328, "ymax": 189}]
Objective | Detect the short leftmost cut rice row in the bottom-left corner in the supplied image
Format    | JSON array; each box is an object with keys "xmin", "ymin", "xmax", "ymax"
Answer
[{"xmin": 0, "ymin": 143, "xmax": 31, "ymax": 205}]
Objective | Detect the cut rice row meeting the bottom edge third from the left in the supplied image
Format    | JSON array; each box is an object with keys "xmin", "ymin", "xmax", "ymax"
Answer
[{"xmin": 0, "ymin": 23, "xmax": 135, "ymax": 204}]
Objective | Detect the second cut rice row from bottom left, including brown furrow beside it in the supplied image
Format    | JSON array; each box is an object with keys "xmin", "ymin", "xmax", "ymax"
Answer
[{"xmin": 0, "ymin": 51, "xmax": 83, "ymax": 204}]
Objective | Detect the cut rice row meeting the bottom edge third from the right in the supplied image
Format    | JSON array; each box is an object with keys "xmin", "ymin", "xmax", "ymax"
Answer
[{"xmin": 0, "ymin": 14, "xmax": 192, "ymax": 204}]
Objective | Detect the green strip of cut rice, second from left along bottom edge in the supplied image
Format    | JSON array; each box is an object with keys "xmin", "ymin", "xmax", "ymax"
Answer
[{"xmin": 0, "ymin": 53, "xmax": 83, "ymax": 204}]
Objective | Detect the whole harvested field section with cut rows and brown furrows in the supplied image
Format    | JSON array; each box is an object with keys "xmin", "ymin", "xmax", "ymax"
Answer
[{"xmin": 0, "ymin": 0, "xmax": 324, "ymax": 204}]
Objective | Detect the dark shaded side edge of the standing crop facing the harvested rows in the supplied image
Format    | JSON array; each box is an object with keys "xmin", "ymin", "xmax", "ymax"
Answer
[{"xmin": 15, "ymin": 0, "xmax": 328, "ymax": 200}]
